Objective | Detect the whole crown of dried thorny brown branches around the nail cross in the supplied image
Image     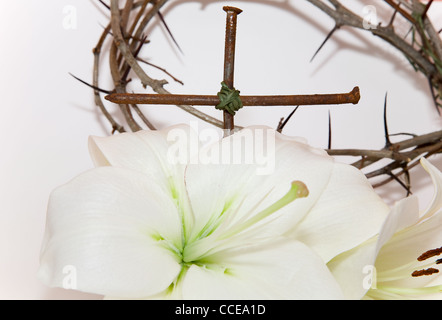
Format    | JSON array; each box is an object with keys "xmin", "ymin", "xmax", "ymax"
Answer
[{"xmin": 85, "ymin": 0, "xmax": 442, "ymax": 193}]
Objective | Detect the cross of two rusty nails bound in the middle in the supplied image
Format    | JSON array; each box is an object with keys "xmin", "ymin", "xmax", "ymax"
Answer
[{"xmin": 105, "ymin": 6, "xmax": 360, "ymax": 135}]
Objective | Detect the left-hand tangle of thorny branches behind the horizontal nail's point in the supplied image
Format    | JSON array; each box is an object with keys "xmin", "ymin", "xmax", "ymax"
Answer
[{"xmin": 93, "ymin": 0, "xmax": 228, "ymax": 133}]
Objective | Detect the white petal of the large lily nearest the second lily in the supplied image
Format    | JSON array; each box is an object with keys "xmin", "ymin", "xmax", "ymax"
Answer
[{"xmin": 292, "ymin": 163, "xmax": 390, "ymax": 262}]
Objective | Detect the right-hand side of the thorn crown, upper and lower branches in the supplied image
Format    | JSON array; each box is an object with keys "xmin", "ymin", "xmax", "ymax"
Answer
[{"xmin": 307, "ymin": 0, "xmax": 442, "ymax": 194}]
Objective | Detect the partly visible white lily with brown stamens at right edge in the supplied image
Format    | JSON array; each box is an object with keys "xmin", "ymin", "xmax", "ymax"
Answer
[{"xmin": 329, "ymin": 158, "xmax": 442, "ymax": 300}]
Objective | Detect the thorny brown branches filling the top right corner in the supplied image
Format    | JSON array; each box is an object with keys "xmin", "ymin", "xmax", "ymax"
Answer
[{"xmin": 307, "ymin": 0, "xmax": 442, "ymax": 114}]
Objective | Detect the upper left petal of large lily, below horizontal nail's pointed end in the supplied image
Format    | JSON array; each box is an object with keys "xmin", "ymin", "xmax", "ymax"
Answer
[{"xmin": 89, "ymin": 125, "xmax": 199, "ymax": 194}]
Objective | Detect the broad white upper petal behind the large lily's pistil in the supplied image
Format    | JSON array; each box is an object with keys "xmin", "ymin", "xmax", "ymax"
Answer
[{"xmin": 185, "ymin": 127, "xmax": 333, "ymax": 242}]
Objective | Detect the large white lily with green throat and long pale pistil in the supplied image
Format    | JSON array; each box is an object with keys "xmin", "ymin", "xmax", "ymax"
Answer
[{"xmin": 39, "ymin": 126, "xmax": 389, "ymax": 299}]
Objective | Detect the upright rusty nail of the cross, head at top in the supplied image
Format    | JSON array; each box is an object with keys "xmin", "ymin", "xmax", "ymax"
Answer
[{"xmin": 223, "ymin": 6, "xmax": 242, "ymax": 135}]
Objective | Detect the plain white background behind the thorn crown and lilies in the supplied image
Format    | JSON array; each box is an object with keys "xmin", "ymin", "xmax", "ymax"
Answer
[{"xmin": 0, "ymin": 0, "xmax": 442, "ymax": 299}]
